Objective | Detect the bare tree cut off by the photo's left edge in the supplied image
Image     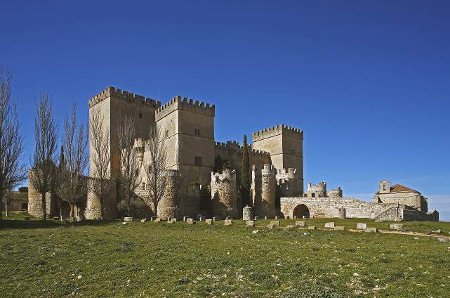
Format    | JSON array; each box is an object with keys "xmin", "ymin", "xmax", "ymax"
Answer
[{"xmin": 0, "ymin": 68, "xmax": 26, "ymax": 219}]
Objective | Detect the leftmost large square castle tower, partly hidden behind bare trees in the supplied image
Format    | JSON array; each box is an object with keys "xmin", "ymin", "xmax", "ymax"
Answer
[{"xmin": 85, "ymin": 87, "xmax": 161, "ymax": 219}]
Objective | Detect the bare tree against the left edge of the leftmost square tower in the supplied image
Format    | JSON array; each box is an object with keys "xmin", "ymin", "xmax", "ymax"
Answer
[{"xmin": 89, "ymin": 110, "xmax": 112, "ymax": 219}]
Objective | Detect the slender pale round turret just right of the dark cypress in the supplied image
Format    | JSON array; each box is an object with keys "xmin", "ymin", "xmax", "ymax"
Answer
[{"xmin": 252, "ymin": 164, "xmax": 276, "ymax": 218}]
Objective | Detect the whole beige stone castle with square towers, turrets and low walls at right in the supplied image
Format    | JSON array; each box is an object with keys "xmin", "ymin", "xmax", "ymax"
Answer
[{"xmin": 29, "ymin": 87, "xmax": 439, "ymax": 220}]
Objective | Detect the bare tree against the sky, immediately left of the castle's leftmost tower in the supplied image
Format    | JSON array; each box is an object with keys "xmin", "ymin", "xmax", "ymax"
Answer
[{"xmin": 55, "ymin": 104, "xmax": 88, "ymax": 219}]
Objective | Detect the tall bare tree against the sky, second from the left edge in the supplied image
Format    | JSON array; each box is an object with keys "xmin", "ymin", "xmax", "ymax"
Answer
[{"xmin": 30, "ymin": 92, "xmax": 58, "ymax": 220}]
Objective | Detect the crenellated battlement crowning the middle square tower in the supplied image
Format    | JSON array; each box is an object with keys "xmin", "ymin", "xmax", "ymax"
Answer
[{"xmin": 156, "ymin": 96, "xmax": 216, "ymax": 120}]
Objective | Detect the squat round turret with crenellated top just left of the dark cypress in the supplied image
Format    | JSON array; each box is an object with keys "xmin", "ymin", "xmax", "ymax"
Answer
[{"xmin": 211, "ymin": 169, "xmax": 238, "ymax": 218}]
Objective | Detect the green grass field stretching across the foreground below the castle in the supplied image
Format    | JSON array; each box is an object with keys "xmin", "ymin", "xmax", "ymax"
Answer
[{"xmin": 0, "ymin": 214, "xmax": 450, "ymax": 297}]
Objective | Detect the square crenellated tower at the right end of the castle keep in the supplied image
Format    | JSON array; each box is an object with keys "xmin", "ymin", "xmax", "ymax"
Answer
[{"xmin": 252, "ymin": 125, "xmax": 303, "ymax": 195}]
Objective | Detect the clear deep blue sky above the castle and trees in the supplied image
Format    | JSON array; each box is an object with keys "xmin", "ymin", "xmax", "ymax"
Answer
[{"xmin": 0, "ymin": 0, "xmax": 450, "ymax": 220}]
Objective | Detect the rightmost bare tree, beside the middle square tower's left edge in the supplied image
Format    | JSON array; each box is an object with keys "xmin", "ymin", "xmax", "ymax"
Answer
[{"xmin": 144, "ymin": 129, "xmax": 169, "ymax": 215}]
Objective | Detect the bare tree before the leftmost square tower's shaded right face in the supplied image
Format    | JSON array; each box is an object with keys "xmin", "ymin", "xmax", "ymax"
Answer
[{"xmin": 118, "ymin": 117, "xmax": 141, "ymax": 216}]
